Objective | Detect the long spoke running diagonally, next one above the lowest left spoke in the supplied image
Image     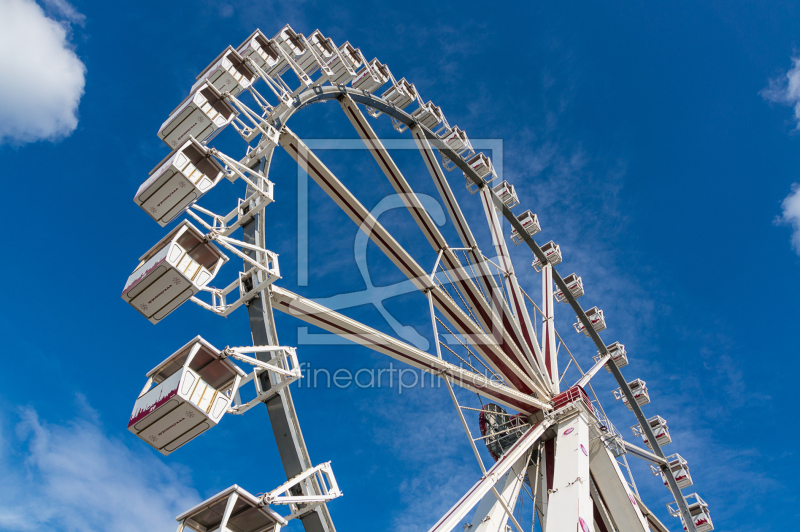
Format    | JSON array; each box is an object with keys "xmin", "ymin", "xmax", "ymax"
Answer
[{"xmin": 280, "ymin": 127, "xmax": 547, "ymax": 397}]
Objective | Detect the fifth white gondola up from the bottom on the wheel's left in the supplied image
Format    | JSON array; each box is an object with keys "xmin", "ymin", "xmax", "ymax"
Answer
[{"xmin": 158, "ymin": 83, "xmax": 237, "ymax": 149}]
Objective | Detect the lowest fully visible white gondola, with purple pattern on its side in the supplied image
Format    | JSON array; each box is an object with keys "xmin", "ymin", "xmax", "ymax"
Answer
[{"xmin": 128, "ymin": 336, "xmax": 246, "ymax": 455}]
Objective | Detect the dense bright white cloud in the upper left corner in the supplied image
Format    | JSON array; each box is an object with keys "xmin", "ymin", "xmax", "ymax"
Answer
[{"xmin": 0, "ymin": 0, "xmax": 86, "ymax": 145}]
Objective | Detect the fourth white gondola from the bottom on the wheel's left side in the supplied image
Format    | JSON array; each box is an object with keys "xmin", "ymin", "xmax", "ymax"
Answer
[{"xmin": 133, "ymin": 138, "xmax": 225, "ymax": 227}]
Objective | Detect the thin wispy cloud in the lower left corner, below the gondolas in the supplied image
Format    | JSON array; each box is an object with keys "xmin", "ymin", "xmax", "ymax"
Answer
[{"xmin": 0, "ymin": 397, "xmax": 200, "ymax": 532}]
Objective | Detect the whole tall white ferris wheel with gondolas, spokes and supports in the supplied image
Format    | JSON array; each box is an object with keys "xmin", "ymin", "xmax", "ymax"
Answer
[{"xmin": 122, "ymin": 25, "xmax": 714, "ymax": 532}]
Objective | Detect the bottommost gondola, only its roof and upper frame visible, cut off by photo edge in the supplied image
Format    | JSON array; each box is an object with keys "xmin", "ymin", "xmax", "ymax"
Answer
[{"xmin": 175, "ymin": 484, "xmax": 287, "ymax": 532}]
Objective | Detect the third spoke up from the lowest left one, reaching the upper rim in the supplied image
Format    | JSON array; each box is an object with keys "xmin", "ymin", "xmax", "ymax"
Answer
[{"xmin": 339, "ymin": 96, "xmax": 552, "ymax": 390}]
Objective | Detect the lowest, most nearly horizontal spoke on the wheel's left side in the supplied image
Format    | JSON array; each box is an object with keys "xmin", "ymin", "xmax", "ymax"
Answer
[{"xmin": 270, "ymin": 286, "xmax": 552, "ymax": 414}]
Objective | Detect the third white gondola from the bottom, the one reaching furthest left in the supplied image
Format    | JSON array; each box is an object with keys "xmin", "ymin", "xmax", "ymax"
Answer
[{"xmin": 122, "ymin": 221, "xmax": 228, "ymax": 323}]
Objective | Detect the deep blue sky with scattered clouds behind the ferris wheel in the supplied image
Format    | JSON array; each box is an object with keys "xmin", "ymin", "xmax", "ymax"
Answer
[{"xmin": 0, "ymin": 0, "xmax": 800, "ymax": 532}]
